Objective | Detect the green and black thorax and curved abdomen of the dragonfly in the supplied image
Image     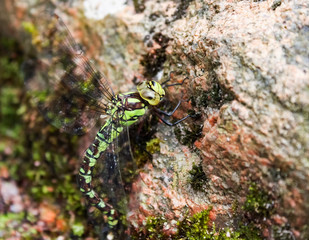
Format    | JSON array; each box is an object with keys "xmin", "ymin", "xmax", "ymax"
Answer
[{"xmin": 78, "ymin": 93, "xmax": 147, "ymax": 218}]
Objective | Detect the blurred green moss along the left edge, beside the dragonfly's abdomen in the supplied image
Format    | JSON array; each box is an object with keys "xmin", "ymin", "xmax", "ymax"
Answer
[{"xmin": 0, "ymin": 23, "xmax": 103, "ymax": 240}]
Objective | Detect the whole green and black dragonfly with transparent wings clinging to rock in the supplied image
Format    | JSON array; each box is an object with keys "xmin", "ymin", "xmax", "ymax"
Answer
[{"xmin": 24, "ymin": 14, "xmax": 192, "ymax": 239}]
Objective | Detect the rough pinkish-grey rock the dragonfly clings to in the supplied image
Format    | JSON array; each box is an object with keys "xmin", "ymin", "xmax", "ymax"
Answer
[{"xmin": 3, "ymin": 0, "xmax": 309, "ymax": 239}]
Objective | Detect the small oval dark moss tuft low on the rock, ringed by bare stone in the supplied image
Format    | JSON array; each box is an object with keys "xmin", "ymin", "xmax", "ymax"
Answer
[{"xmin": 188, "ymin": 165, "xmax": 208, "ymax": 191}]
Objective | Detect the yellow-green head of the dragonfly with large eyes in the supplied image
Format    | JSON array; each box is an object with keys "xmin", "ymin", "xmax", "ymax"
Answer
[{"xmin": 137, "ymin": 81, "xmax": 165, "ymax": 105}]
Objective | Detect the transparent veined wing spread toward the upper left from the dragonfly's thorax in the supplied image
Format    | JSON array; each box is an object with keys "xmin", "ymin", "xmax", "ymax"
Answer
[{"xmin": 23, "ymin": 14, "xmax": 114, "ymax": 134}]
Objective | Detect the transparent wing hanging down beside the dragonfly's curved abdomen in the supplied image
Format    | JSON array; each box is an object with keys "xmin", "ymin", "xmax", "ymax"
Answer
[{"xmin": 86, "ymin": 116, "xmax": 134, "ymax": 239}]
